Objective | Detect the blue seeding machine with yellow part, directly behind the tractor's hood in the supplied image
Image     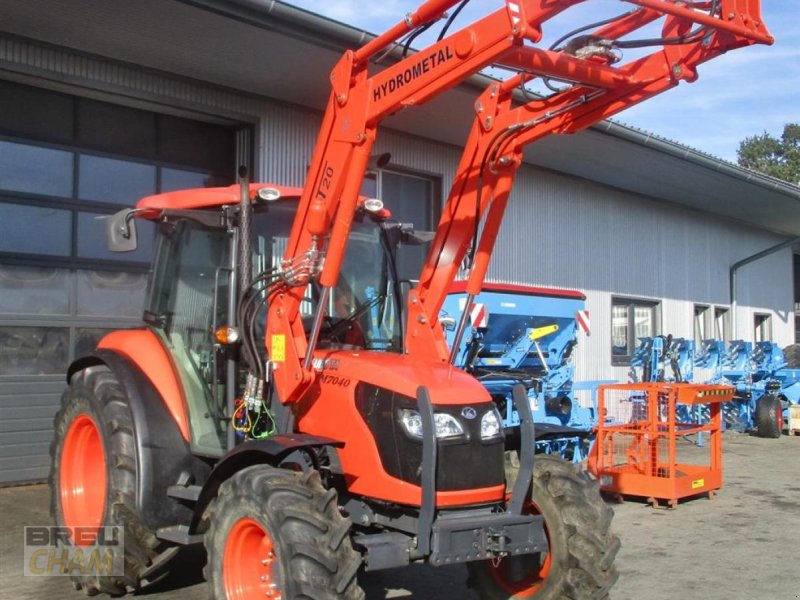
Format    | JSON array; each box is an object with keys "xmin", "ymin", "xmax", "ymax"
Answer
[{"xmin": 442, "ymin": 283, "xmax": 607, "ymax": 462}]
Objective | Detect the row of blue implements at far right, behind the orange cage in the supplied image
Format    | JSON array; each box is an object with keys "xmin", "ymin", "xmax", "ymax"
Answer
[{"xmin": 631, "ymin": 336, "xmax": 800, "ymax": 437}]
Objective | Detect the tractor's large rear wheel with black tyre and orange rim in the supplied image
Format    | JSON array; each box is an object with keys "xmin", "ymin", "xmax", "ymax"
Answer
[{"xmin": 50, "ymin": 366, "xmax": 174, "ymax": 596}]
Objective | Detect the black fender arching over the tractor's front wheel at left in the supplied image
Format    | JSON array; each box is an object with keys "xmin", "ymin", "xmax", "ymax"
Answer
[{"xmin": 190, "ymin": 433, "xmax": 344, "ymax": 533}]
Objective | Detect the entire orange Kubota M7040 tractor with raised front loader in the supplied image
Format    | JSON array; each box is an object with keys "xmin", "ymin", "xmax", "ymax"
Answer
[{"xmin": 51, "ymin": 0, "xmax": 771, "ymax": 600}]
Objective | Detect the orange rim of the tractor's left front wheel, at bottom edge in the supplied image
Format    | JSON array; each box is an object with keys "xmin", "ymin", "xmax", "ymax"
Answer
[{"xmin": 222, "ymin": 517, "xmax": 281, "ymax": 600}]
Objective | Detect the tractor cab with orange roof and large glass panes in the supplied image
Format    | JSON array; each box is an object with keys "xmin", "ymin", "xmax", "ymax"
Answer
[{"xmin": 109, "ymin": 184, "xmax": 410, "ymax": 457}]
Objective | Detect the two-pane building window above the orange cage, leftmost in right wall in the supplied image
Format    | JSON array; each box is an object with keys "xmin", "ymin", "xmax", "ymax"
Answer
[{"xmin": 611, "ymin": 298, "xmax": 660, "ymax": 365}]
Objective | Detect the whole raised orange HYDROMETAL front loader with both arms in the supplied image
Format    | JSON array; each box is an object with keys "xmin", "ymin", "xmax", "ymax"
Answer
[{"xmin": 266, "ymin": 0, "xmax": 772, "ymax": 403}]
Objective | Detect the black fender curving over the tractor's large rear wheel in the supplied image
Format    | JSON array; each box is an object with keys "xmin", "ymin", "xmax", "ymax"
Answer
[{"xmin": 68, "ymin": 349, "xmax": 211, "ymax": 531}]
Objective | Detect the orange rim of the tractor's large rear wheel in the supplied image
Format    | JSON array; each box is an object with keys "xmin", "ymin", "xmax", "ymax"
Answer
[{"xmin": 59, "ymin": 414, "xmax": 107, "ymax": 545}]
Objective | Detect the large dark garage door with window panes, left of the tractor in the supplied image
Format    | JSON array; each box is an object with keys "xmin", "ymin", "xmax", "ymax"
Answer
[{"xmin": 0, "ymin": 81, "xmax": 236, "ymax": 485}]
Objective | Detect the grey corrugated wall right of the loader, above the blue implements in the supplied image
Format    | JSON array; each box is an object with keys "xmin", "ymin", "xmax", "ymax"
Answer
[{"xmin": 490, "ymin": 168, "xmax": 794, "ymax": 380}]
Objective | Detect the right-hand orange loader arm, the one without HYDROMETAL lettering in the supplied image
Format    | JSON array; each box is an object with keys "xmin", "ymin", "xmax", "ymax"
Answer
[{"xmin": 406, "ymin": 0, "xmax": 772, "ymax": 360}]
